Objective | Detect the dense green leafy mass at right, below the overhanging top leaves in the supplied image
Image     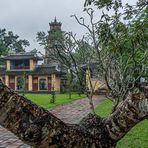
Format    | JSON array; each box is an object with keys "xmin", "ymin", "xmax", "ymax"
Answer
[{"xmin": 98, "ymin": 5, "xmax": 148, "ymax": 98}]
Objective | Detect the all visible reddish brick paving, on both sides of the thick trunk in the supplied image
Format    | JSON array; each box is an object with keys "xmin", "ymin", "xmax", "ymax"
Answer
[{"xmin": 0, "ymin": 96, "xmax": 104, "ymax": 148}]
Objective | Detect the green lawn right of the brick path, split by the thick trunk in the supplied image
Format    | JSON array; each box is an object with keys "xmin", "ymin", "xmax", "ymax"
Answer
[{"xmin": 95, "ymin": 100, "xmax": 148, "ymax": 148}]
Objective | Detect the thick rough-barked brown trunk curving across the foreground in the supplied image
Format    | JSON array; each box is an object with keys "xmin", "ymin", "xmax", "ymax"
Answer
[{"xmin": 0, "ymin": 82, "xmax": 148, "ymax": 148}]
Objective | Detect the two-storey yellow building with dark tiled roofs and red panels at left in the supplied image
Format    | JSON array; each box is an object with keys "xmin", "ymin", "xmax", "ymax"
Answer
[{"xmin": 0, "ymin": 52, "xmax": 62, "ymax": 92}]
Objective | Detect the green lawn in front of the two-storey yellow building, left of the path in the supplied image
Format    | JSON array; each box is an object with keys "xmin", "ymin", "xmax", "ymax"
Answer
[{"xmin": 25, "ymin": 93, "xmax": 85, "ymax": 109}]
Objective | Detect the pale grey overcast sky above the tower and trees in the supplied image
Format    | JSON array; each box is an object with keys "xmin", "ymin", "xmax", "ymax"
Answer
[{"xmin": 0, "ymin": 0, "xmax": 135, "ymax": 51}]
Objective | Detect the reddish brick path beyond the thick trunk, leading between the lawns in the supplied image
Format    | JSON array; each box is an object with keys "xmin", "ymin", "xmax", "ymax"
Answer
[{"xmin": 49, "ymin": 96, "xmax": 104, "ymax": 124}]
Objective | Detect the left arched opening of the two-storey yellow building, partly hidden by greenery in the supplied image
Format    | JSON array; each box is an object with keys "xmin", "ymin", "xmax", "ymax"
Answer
[{"xmin": 16, "ymin": 77, "xmax": 25, "ymax": 90}]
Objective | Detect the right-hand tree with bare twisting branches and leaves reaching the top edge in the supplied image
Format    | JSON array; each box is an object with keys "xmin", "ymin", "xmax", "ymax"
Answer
[{"xmin": 77, "ymin": 0, "xmax": 148, "ymax": 108}]
